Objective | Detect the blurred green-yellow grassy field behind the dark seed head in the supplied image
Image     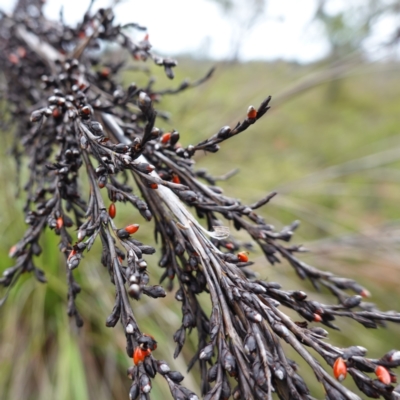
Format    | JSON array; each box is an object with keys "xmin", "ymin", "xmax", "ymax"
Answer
[{"xmin": 0, "ymin": 2, "xmax": 400, "ymax": 400}]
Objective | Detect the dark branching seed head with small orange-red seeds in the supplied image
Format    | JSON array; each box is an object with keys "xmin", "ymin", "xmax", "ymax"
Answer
[{"xmin": 0, "ymin": 0, "xmax": 400, "ymax": 400}]
